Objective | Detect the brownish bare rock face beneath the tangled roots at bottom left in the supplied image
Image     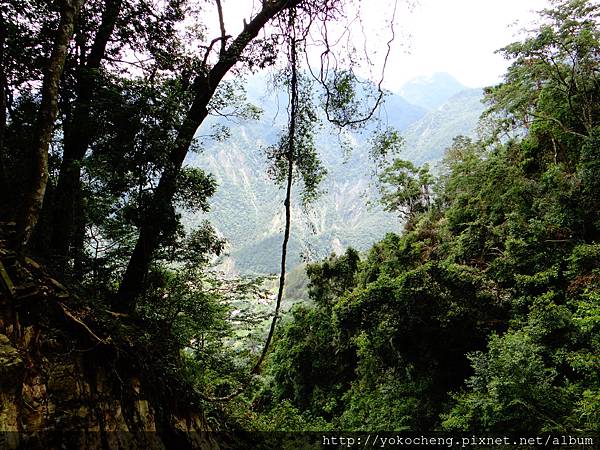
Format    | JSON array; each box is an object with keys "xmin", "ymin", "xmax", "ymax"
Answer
[{"xmin": 0, "ymin": 326, "xmax": 214, "ymax": 449}]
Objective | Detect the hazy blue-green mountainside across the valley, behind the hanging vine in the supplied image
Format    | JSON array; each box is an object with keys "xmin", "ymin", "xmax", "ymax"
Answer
[{"xmin": 186, "ymin": 74, "xmax": 480, "ymax": 275}]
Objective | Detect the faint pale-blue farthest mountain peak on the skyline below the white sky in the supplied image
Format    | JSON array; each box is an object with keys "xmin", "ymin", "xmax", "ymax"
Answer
[{"xmin": 399, "ymin": 72, "xmax": 467, "ymax": 110}]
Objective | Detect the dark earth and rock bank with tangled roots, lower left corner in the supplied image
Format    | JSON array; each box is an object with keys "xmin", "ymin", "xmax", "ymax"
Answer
[{"xmin": 0, "ymin": 244, "xmax": 216, "ymax": 449}]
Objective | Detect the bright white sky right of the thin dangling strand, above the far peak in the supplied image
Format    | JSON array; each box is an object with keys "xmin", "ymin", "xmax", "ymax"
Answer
[{"xmin": 378, "ymin": 0, "xmax": 549, "ymax": 90}]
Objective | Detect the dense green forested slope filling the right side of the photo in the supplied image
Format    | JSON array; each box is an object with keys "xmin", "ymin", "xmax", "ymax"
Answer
[{"xmin": 240, "ymin": 1, "xmax": 600, "ymax": 435}]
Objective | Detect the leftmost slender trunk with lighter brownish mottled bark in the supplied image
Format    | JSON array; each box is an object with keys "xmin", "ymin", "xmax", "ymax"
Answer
[{"xmin": 16, "ymin": 0, "xmax": 85, "ymax": 252}]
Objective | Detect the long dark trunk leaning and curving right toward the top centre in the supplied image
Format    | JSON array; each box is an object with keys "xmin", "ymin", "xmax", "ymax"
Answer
[{"xmin": 117, "ymin": 0, "xmax": 301, "ymax": 309}]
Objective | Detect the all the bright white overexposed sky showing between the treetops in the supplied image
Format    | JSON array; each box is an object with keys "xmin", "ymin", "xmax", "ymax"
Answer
[{"xmin": 216, "ymin": 0, "xmax": 550, "ymax": 92}]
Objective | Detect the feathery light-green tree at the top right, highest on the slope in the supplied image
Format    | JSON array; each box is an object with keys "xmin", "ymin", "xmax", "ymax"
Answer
[{"xmin": 487, "ymin": 0, "xmax": 600, "ymax": 146}]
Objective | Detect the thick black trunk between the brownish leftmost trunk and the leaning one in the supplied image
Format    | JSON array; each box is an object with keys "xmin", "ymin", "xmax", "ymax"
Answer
[{"xmin": 49, "ymin": 0, "xmax": 122, "ymax": 261}]
